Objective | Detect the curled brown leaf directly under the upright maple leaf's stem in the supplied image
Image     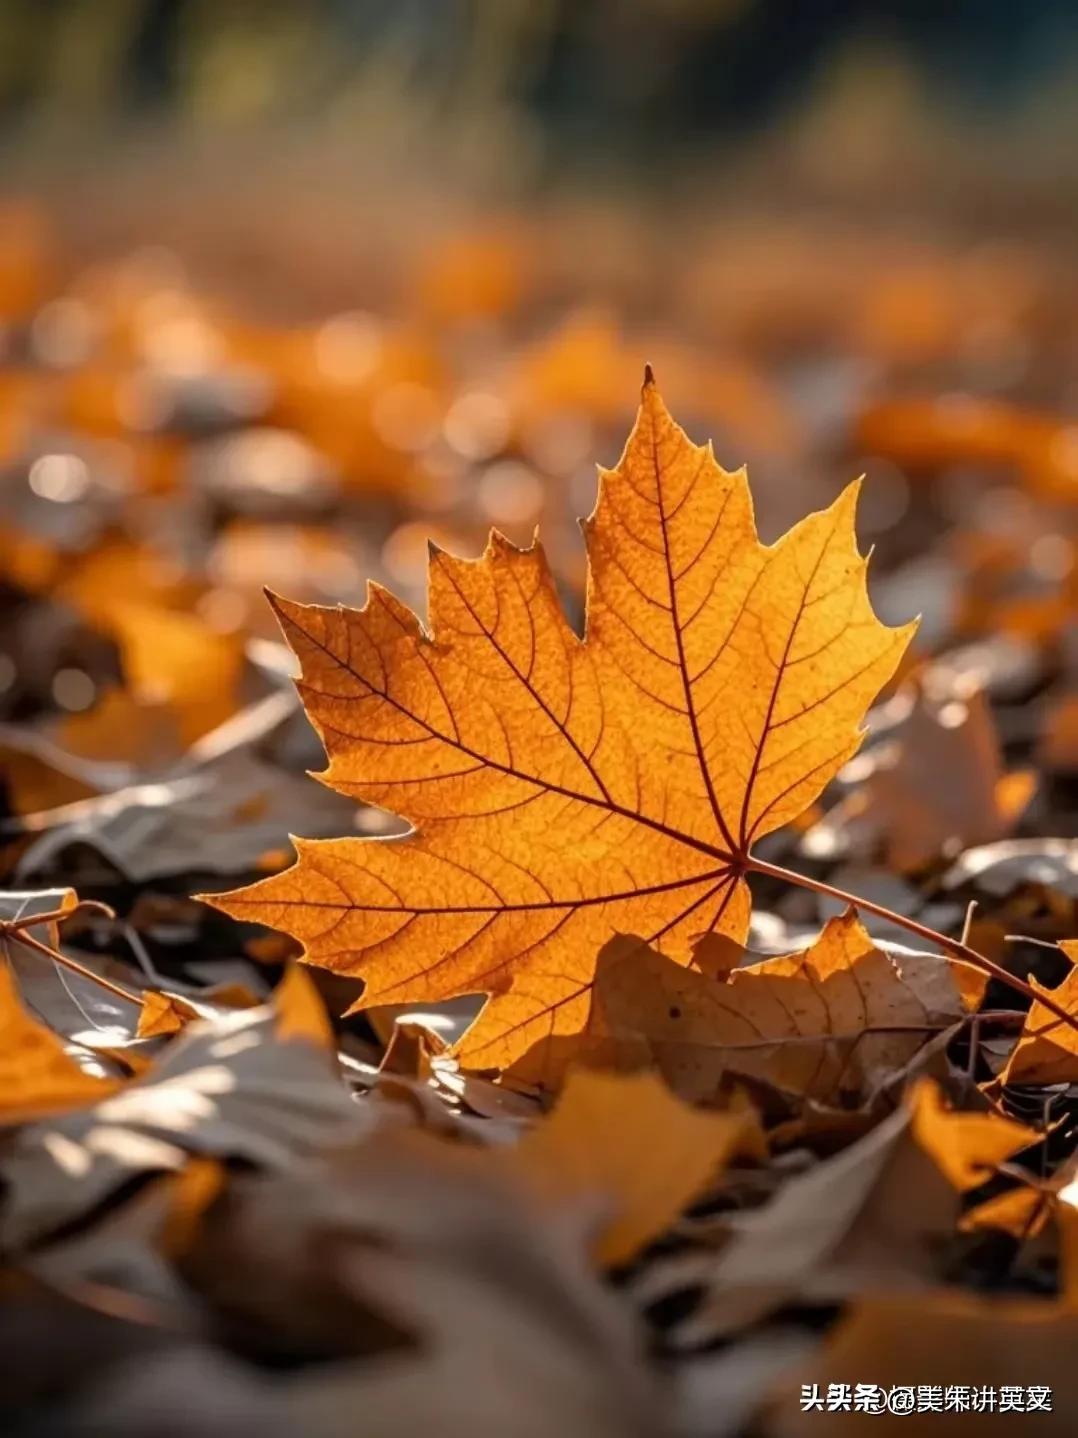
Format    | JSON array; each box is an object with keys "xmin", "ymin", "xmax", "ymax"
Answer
[{"xmin": 583, "ymin": 910, "xmax": 985, "ymax": 1103}]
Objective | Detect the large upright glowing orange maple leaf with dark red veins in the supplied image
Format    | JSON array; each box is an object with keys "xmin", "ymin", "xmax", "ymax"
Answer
[{"xmin": 207, "ymin": 372, "xmax": 913, "ymax": 1068}]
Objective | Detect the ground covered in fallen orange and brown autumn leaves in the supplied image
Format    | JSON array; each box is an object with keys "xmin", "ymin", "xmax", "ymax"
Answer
[{"xmin": 0, "ymin": 197, "xmax": 1078, "ymax": 1438}]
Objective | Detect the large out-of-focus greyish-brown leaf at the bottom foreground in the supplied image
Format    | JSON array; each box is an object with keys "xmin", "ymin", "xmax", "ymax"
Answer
[{"xmin": 76, "ymin": 1133, "xmax": 665, "ymax": 1438}]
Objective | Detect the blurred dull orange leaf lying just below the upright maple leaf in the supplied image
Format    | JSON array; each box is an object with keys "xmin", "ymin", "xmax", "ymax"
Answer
[{"xmin": 509, "ymin": 1068, "xmax": 765, "ymax": 1265}]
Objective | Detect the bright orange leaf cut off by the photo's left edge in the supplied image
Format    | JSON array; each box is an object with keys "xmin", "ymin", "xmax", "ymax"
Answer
[{"xmin": 0, "ymin": 961, "xmax": 119, "ymax": 1123}]
